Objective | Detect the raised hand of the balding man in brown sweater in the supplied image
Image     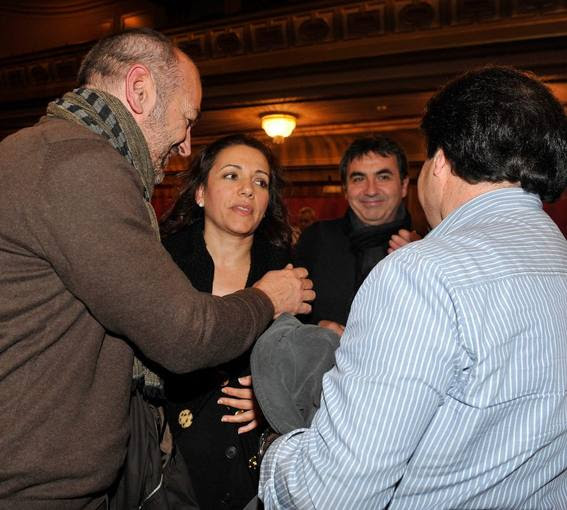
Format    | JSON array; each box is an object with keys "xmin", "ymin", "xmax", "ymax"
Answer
[{"xmin": 253, "ymin": 264, "xmax": 315, "ymax": 317}]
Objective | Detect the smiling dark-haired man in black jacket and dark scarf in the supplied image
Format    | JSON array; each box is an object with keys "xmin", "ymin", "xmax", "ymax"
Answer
[{"xmin": 295, "ymin": 136, "xmax": 419, "ymax": 334}]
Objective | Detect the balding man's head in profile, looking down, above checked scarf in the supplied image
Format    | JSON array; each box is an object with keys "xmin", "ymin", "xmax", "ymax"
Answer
[{"xmin": 78, "ymin": 29, "xmax": 202, "ymax": 182}]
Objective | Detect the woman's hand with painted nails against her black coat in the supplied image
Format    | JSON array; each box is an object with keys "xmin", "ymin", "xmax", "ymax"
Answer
[{"xmin": 217, "ymin": 375, "xmax": 263, "ymax": 434}]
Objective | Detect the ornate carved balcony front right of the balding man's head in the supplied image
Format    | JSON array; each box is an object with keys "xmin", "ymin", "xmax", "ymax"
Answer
[{"xmin": 169, "ymin": 0, "xmax": 567, "ymax": 66}]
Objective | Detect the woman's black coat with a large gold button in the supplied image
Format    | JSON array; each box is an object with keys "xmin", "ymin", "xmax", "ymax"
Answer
[{"xmin": 164, "ymin": 222, "xmax": 289, "ymax": 510}]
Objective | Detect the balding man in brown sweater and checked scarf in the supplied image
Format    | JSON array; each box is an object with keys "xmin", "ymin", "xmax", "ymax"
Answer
[{"xmin": 0, "ymin": 30, "xmax": 314, "ymax": 510}]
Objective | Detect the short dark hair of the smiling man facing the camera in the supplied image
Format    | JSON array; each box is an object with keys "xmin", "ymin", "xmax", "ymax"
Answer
[{"xmin": 339, "ymin": 135, "xmax": 408, "ymax": 186}]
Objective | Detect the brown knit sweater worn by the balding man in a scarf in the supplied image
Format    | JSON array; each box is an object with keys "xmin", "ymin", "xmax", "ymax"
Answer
[{"xmin": 0, "ymin": 119, "xmax": 273, "ymax": 509}]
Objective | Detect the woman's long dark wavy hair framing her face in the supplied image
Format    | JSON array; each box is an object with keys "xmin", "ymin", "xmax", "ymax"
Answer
[{"xmin": 161, "ymin": 134, "xmax": 291, "ymax": 247}]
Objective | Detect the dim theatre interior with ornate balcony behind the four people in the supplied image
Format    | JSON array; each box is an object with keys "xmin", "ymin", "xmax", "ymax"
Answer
[{"xmin": 0, "ymin": 0, "xmax": 567, "ymax": 233}]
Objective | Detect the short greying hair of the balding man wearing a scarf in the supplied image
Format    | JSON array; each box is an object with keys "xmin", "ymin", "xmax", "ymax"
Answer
[{"xmin": 77, "ymin": 28, "xmax": 179, "ymax": 99}]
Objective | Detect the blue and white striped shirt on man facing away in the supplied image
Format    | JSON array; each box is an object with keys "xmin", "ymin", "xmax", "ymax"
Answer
[{"xmin": 260, "ymin": 188, "xmax": 567, "ymax": 510}]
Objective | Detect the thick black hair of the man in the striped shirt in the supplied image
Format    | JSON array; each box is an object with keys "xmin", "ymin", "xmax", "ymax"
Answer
[{"xmin": 421, "ymin": 66, "xmax": 567, "ymax": 201}]
